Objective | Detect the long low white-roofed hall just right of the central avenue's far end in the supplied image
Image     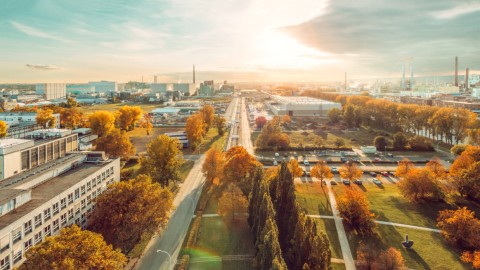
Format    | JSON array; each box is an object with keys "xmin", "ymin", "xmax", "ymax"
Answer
[{"xmin": 266, "ymin": 95, "xmax": 342, "ymax": 117}]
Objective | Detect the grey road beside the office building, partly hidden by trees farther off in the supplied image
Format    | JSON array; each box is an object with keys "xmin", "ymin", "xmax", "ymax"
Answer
[{"xmin": 136, "ymin": 98, "xmax": 238, "ymax": 270}]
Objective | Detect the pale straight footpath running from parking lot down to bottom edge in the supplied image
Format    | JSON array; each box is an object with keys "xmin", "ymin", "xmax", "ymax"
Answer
[{"xmin": 327, "ymin": 181, "xmax": 356, "ymax": 270}]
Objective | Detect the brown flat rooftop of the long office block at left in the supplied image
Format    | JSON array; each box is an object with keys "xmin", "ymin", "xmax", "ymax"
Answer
[{"xmin": 0, "ymin": 160, "xmax": 113, "ymax": 230}]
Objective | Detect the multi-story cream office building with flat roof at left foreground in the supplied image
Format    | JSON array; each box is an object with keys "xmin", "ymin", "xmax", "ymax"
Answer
[{"xmin": 0, "ymin": 132, "xmax": 120, "ymax": 270}]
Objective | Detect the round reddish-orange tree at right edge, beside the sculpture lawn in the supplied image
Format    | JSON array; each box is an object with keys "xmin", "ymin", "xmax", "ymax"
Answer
[{"xmin": 437, "ymin": 207, "xmax": 480, "ymax": 249}]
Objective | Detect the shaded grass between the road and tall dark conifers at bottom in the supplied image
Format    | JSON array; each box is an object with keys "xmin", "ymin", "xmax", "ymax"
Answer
[{"xmin": 186, "ymin": 217, "xmax": 254, "ymax": 269}]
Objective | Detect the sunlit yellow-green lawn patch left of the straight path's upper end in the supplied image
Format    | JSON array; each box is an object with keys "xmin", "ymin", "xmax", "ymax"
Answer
[{"xmin": 295, "ymin": 182, "xmax": 332, "ymax": 216}]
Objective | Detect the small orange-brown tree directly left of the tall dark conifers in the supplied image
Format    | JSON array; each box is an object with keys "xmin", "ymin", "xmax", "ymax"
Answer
[{"xmin": 217, "ymin": 183, "xmax": 248, "ymax": 222}]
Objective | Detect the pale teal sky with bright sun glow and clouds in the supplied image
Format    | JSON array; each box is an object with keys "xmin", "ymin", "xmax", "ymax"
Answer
[{"xmin": 0, "ymin": 0, "xmax": 480, "ymax": 83}]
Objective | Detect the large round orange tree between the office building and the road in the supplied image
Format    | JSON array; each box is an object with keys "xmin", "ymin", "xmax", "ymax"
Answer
[{"xmin": 88, "ymin": 175, "xmax": 173, "ymax": 253}]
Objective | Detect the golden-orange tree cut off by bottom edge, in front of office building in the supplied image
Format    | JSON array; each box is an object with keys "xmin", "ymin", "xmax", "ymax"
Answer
[{"xmin": 18, "ymin": 225, "xmax": 127, "ymax": 270}]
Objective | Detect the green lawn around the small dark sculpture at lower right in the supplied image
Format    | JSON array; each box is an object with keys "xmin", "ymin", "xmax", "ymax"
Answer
[{"xmin": 348, "ymin": 225, "xmax": 471, "ymax": 270}]
